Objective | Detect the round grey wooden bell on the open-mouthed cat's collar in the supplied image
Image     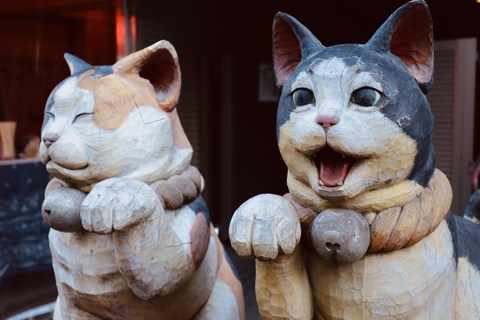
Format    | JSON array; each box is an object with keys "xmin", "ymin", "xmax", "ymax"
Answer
[{"xmin": 311, "ymin": 209, "xmax": 370, "ymax": 264}]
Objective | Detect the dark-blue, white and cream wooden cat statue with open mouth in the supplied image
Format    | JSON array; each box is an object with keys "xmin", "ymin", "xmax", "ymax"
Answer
[{"xmin": 230, "ymin": 1, "xmax": 480, "ymax": 320}]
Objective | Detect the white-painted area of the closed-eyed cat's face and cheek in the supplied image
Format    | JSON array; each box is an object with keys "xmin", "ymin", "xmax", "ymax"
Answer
[{"xmin": 40, "ymin": 77, "xmax": 192, "ymax": 192}]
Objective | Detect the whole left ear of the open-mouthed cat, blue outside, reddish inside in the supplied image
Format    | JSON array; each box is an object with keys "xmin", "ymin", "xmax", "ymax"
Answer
[{"xmin": 273, "ymin": 12, "xmax": 325, "ymax": 86}]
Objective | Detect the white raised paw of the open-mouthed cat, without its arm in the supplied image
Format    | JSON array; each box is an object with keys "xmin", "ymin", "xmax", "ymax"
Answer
[{"xmin": 229, "ymin": 194, "xmax": 301, "ymax": 260}]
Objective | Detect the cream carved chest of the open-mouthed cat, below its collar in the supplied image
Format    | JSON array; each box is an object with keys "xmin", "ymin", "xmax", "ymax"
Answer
[{"xmin": 307, "ymin": 221, "xmax": 455, "ymax": 320}]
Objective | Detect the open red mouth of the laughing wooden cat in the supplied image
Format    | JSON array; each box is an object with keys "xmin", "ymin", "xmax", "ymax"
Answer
[{"xmin": 314, "ymin": 147, "xmax": 356, "ymax": 188}]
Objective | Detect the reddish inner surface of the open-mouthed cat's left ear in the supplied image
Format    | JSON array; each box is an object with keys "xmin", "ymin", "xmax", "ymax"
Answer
[{"xmin": 273, "ymin": 16, "xmax": 302, "ymax": 86}]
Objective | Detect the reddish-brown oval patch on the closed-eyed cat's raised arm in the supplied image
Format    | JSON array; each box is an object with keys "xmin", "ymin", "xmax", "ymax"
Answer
[{"xmin": 190, "ymin": 212, "xmax": 210, "ymax": 268}]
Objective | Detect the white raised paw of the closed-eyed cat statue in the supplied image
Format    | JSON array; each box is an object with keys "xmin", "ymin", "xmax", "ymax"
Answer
[{"xmin": 80, "ymin": 178, "xmax": 161, "ymax": 234}]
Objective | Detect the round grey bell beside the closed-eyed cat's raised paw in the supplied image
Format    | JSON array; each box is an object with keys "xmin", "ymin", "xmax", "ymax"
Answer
[{"xmin": 42, "ymin": 188, "xmax": 86, "ymax": 232}]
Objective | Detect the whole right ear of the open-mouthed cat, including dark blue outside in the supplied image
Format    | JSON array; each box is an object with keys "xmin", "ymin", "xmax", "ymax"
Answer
[{"xmin": 366, "ymin": 0, "xmax": 433, "ymax": 94}]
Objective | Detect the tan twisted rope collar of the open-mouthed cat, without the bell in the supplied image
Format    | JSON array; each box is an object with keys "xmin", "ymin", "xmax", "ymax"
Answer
[{"xmin": 284, "ymin": 169, "xmax": 452, "ymax": 253}]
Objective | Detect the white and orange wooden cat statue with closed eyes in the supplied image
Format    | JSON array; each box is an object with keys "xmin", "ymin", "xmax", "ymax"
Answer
[{"xmin": 40, "ymin": 41, "xmax": 245, "ymax": 320}]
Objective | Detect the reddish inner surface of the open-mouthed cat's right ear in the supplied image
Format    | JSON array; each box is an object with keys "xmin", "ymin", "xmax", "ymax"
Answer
[{"xmin": 390, "ymin": 4, "xmax": 433, "ymax": 83}]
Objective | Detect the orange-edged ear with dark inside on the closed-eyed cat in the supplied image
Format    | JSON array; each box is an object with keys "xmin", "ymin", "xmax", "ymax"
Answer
[{"xmin": 113, "ymin": 40, "xmax": 181, "ymax": 111}]
